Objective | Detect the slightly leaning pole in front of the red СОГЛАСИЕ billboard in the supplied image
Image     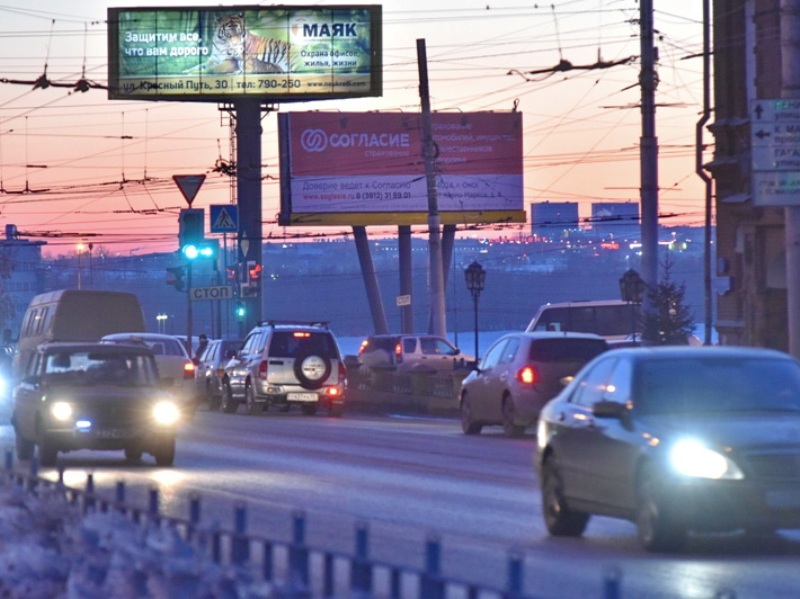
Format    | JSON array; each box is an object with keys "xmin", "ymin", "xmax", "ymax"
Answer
[{"xmin": 417, "ymin": 39, "xmax": 447, "ymax": 337}]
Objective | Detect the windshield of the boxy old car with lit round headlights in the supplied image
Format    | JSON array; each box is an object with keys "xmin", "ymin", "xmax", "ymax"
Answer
[{"xmin": 43, "ymin": 351, "xmax": 158, "ymax": 387}]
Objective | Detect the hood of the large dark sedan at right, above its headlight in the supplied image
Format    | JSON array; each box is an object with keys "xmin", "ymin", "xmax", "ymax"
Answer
[{"xmin": 640, "ymin": 411, "xmax": 800, "ymax": 449}]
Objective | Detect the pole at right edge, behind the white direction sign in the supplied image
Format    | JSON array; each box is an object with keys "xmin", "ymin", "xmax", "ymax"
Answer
[{"xmin": 780, "ymin": 0, "xmax": 800, "ymax": 358}]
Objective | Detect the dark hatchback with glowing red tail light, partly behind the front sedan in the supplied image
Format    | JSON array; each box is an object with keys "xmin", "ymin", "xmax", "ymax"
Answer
[{"xmin": 459, "ymin": 333, "xmax": 609, "ymax": 437}]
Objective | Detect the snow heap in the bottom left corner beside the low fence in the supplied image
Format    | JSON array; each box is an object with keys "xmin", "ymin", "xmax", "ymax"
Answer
[{"xmin": 0, "ymin": 480, "xmax": 288, "ymax": 599}]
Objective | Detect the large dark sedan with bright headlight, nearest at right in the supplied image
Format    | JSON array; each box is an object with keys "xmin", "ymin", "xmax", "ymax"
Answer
[{"xmin": 535, "ymin": 346, "xmax": 800, "ymax": 551}]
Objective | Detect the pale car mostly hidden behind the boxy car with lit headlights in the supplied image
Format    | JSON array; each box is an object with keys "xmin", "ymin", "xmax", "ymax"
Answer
[{"xmin": 101, "ymin": 332, "xmax": 198, "ymax": 415}]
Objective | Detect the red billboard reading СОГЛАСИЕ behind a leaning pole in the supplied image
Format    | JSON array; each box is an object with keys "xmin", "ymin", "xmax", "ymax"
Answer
[{"xmin": 278, "ymin": 112, "xmax": 525, "ymax": 226}]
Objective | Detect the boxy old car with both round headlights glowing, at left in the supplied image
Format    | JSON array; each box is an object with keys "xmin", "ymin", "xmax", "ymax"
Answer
[{"xmin": 11, "ymin": 342, "xmax": 180, "ymax": 466}]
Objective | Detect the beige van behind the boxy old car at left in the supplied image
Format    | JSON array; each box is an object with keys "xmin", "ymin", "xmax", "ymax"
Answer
[{"xmin": 13, "ymin": 289, "xmax": 145, "ymax": 374}]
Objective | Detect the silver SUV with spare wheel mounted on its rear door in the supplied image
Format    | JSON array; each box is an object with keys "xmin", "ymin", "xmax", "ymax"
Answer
[{"xmin": 222, "ymin": 321, "xmax": 347, "ymax": 416}]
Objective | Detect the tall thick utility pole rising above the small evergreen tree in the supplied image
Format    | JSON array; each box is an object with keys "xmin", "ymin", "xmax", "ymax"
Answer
[{"xmin": 639, "ymin": 0, "xmax": 658, "ymax": 298}]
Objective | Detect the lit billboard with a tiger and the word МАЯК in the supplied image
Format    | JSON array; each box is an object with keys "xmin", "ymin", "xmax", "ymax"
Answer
[{"xmin": 108, "ymin": 5, "xmax": 382, "ymax": 102}]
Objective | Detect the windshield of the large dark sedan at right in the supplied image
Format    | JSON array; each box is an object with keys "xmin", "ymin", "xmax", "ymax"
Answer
[{"xmin": 634, "ymin": 357, "xmax": 800, "ymax": 414}]
